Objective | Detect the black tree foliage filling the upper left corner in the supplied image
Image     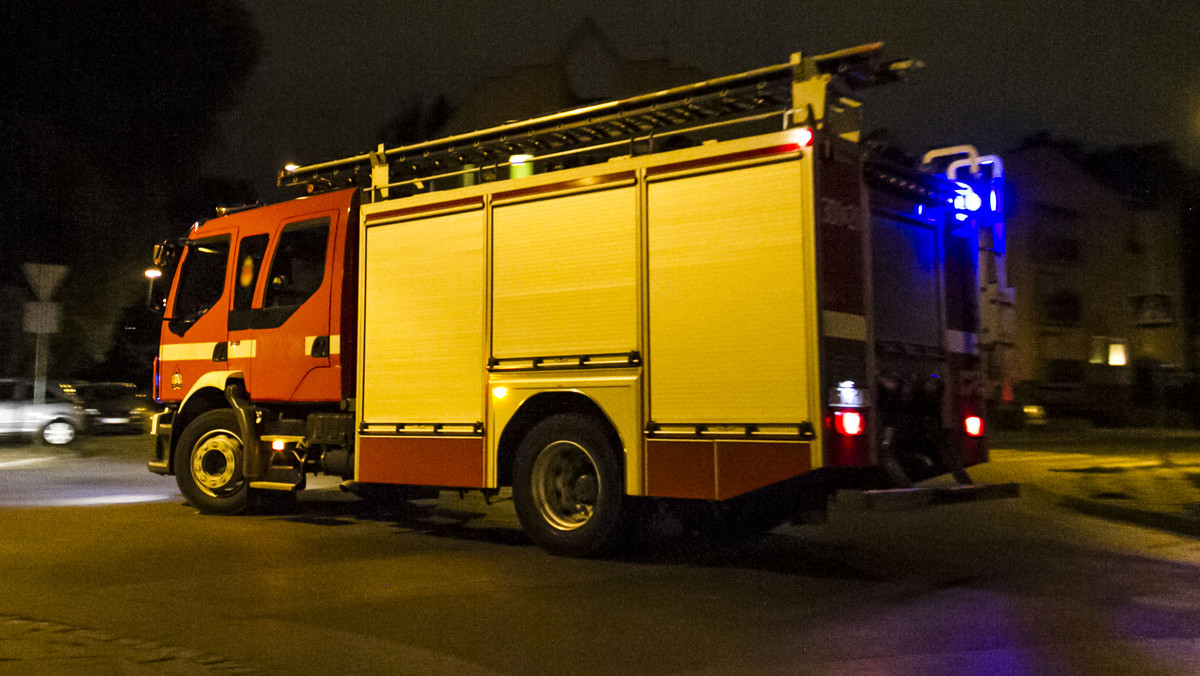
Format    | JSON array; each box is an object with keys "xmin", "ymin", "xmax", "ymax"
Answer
[{"xmin": 0, "ymin": 0, "xmax": 260, "ymax": 376}]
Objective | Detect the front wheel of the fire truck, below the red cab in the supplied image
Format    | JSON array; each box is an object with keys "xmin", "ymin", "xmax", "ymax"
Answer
[{"xmin": 175, "ymin": 408, "xmax": 250, "ymax": 514}]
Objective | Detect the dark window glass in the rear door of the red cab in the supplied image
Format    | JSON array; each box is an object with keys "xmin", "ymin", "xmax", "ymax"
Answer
[{"xmin": 263, "ymin": 217, "xmax": 329, "ymax": 309}]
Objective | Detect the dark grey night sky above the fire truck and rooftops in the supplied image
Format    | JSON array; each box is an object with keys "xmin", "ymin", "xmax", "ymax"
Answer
[{"xmin": 211, "ymin": 0, "xmax": 1200, "ymax": 193}]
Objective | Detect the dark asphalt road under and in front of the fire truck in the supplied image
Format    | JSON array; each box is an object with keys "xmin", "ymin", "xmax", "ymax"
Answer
[{"xmin": 0, "ymin": 437, "xmax": 1200, "ymax": 675}]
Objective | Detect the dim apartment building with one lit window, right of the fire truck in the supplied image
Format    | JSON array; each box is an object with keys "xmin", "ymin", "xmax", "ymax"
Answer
[{"xmin": 1004, "ymin": 145, "xmax": 1188, "ymax": 424}]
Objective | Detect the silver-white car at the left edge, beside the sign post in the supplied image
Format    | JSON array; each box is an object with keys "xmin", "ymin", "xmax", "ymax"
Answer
[{"xmin": 0, "ymin": 378, "xmax": 88, "ymax": 445}]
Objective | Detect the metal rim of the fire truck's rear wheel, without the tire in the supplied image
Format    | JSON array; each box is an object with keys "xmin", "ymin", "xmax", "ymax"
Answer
[{"xmin": 530, "ymin": 441, "xmax": 600, "ymax": 531}]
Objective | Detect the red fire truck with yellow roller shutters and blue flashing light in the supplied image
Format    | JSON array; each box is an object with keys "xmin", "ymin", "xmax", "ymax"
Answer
[{"xmin": 148, "ymin": 44, "xmax": 1015, "ymax": 556}]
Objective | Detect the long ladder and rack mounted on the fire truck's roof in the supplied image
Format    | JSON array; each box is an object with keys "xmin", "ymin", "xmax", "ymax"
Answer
[{"xmin": 277, "ymin": 42, "xmax": 920, "ymax": 201}]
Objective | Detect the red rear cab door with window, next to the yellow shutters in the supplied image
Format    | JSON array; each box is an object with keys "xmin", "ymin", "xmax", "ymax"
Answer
[{"xmin": 250, "ymin": 210, "xmax": 341, "ymax": 401}]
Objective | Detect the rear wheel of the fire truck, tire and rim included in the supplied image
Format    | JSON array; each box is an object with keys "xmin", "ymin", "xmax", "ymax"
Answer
[{"xmin": 512, "ymin": 413, "xmax": 625, "ymax": 557}]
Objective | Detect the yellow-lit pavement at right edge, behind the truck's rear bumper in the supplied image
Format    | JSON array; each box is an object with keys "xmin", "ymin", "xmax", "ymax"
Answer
[{"xmin": 972, "ymin": 424, "xmax": 1200, "ymax": 537}]
